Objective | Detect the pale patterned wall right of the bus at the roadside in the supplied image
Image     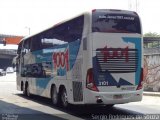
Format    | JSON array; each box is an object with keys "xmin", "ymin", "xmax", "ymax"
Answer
[{"xmin": 144, "ymin": 53, "xmax": 160, "ymax": 92}]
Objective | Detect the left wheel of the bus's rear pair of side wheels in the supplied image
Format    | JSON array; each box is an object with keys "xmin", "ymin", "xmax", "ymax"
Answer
[{"xmin": 51, "ymin": 86, "xmax": 58, "ymax": 105}]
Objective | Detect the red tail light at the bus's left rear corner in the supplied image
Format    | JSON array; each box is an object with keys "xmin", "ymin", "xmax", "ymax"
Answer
[{"xmin": 86, "ymin": 68, "xmax": 99, "ymax": 92}]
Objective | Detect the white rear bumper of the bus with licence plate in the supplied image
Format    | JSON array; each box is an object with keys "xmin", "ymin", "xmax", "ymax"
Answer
[{"xmin": 84, "ymin": 90, "xmax": 143, "ymax": 105}]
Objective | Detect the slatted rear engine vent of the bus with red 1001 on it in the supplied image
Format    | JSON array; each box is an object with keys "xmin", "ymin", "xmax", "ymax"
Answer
[{"xmin": 96, "ymin": 48, "xmax": 138, "ymax": 73}]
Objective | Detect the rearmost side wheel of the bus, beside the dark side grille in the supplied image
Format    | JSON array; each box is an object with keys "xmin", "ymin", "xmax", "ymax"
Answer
[{"xmin": 61, "ymin": 88, "xmax": 69, "ymax": 108}]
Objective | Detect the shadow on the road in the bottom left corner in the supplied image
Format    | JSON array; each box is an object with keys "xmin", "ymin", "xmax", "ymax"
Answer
[{"xmin": 0, "ymin": 100, "xmax": 66, "ymax": 120}]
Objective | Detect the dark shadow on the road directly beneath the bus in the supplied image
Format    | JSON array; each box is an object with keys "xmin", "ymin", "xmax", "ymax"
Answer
[{"xmin": 17, "ymin": 94, "xmax": 142, "ymax": 120}]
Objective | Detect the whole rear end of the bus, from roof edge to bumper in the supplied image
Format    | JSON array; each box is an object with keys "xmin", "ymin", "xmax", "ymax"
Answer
[{"xmin": 85, "ymin": 10, "xmax": 143, "ymax": 104}]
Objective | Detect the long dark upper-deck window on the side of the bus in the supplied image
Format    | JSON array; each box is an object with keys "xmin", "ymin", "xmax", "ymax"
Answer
[{"xmin": 30, "ymin": 15, "xmax": 84, "ymax": 51}]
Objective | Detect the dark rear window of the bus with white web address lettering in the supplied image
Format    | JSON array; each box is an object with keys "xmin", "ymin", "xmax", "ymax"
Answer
[{"xmin": 92, "ymin": 12, "xmax": 141, "ymax": 34}]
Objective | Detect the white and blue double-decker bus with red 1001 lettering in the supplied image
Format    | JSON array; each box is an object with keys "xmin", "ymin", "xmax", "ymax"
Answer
[{"xmin": 16, "ymin": 9, "xmax": 143, "ymax": 107}]
